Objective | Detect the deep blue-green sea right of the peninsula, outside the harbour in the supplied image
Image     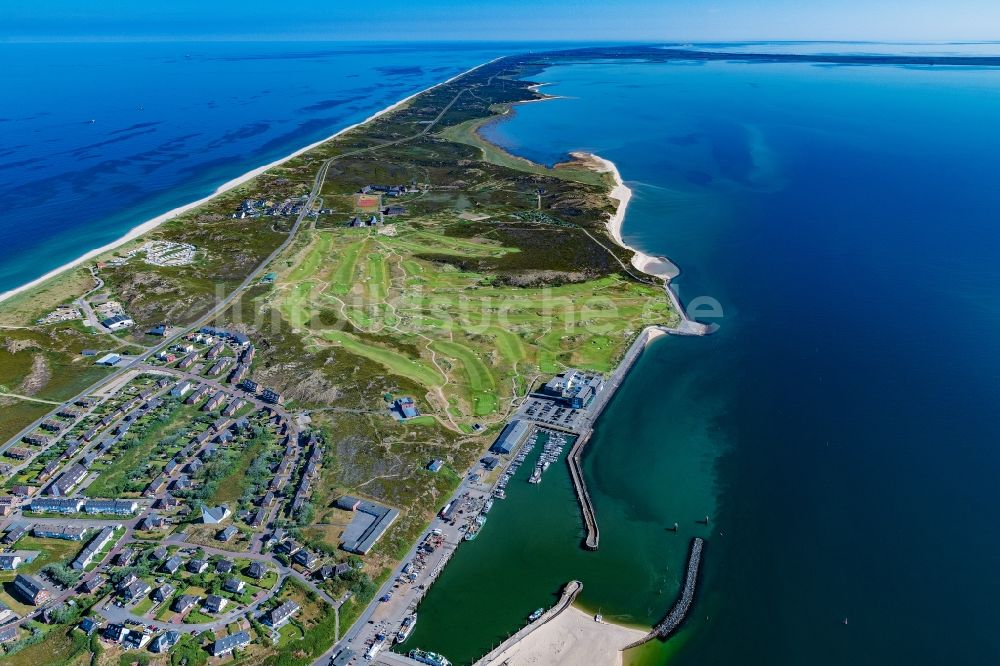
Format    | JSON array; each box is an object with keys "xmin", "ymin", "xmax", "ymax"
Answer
[{"xmin": 478, "ymin": 62, "xmax": 1000, "ymax": 665}]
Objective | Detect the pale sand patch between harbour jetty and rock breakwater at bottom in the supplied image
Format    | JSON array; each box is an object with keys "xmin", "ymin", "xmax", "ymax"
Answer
[{"xmin": 483, "ymin": 606, "xmax": 646, "ymax": 666}]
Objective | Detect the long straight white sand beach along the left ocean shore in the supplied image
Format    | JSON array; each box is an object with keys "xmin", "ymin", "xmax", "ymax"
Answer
[{"xmin": 0, "ymin": 56, "xmax": 503, "ymax": 302}]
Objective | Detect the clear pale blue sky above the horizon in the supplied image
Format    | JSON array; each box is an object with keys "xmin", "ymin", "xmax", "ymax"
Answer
[{"xmin": 0, "ymin": 0, "xmax": 1000, "ymax": 41}]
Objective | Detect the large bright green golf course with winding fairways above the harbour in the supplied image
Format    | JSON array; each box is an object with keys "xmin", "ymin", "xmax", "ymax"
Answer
[{"xmin": 279, "ymin": 218, "xmax": 672, "ymax": 421}]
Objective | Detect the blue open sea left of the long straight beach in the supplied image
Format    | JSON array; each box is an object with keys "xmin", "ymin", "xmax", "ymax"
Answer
[{"xmin": 0, "ymin": 42, "xmax": 556, "ymax": 293}]
